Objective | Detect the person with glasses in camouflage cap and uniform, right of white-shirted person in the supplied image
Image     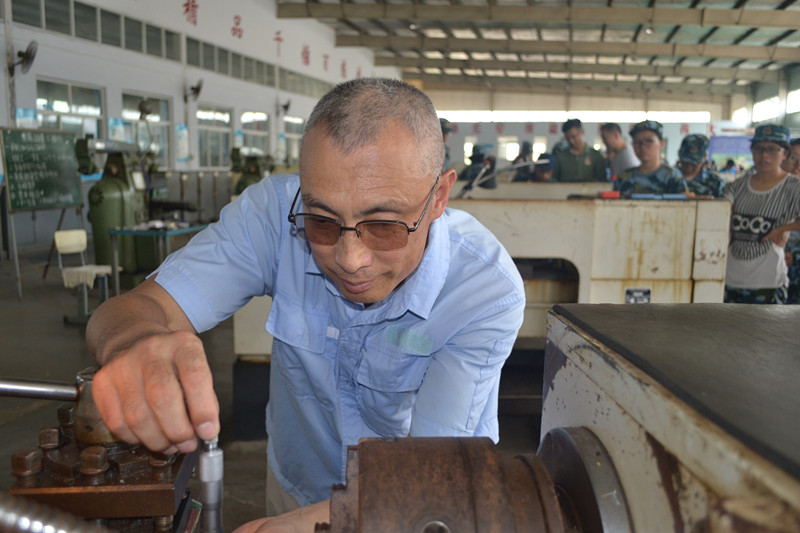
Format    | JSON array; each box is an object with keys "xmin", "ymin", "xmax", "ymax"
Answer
[{"xmin": 614, "ymin": 120, "xmax": 687, "ymax": 197}]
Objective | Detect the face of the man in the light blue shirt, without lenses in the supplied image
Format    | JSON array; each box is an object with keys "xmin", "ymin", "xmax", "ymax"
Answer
[{"xmin": 298, "ymin": 125, "xmax": 456, "ymax": 304}]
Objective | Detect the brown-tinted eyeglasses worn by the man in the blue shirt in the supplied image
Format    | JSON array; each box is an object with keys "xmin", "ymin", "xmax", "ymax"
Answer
[{"xmin": 289, "ymin": 176, "xmax": 441, "ymax": 251}]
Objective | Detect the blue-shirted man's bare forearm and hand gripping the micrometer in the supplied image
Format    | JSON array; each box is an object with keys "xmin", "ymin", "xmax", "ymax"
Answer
[{"xmin": 86, "ymin": 279, "xmax": 219, "ymax": 453}]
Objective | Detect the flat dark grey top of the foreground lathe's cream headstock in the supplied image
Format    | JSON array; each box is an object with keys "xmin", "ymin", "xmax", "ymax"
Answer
[{"xmin": 554, "ymin": 304, "xmax": 800, "ymax": 480}]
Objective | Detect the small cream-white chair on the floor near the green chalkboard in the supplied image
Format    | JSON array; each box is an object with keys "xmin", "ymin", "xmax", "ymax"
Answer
[{"xmin": 53, "ymin": 229, "xmax": 111, "ymax": 324}]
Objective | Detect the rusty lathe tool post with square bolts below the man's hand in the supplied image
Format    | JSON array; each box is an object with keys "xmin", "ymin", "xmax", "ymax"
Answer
[{"xmin": 8, "ymin": 371, "xmax": 197, "ymax": 532}]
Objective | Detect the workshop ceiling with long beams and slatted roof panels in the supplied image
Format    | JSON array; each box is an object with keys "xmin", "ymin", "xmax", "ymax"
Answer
[{"xmin": 278, "ymin": 0, "xmax": 800, "ymax": 98}]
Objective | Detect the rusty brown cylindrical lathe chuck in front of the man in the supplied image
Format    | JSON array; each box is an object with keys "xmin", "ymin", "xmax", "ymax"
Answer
[{"xmin": 319, "ymin": 437, "xmax": 565, "ymax": 533}]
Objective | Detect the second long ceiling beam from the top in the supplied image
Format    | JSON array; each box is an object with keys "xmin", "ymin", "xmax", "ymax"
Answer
[{"xmin": 336, "ymin": 34, "xmax": 800, "ymax": 62}]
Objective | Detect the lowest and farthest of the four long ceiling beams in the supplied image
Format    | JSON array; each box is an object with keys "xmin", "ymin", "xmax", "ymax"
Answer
[{"xmin": 403, "ymin": 73, "xmax": 746, "ymax": 99}]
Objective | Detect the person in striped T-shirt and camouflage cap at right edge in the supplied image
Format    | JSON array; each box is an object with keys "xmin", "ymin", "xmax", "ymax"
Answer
[{"xmin": 725, "ymin": 124, "xmax": 800, "ymax": 304}]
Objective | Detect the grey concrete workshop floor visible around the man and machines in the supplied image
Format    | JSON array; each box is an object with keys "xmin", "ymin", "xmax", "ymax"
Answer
[{"xmin": 0, "ymin": 241, "xmax": 541, "ymax": 531}]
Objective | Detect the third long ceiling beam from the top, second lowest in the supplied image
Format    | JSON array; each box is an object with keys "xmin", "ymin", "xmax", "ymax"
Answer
[{"xmin": 375, "ymin": 56, "xmax": 778, "ymax": 82}]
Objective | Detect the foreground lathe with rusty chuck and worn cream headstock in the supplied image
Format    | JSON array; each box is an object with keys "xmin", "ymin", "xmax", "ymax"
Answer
[{"xmin": 310, "ymin": 304, "xmax": 800, "ymax": 533}]
